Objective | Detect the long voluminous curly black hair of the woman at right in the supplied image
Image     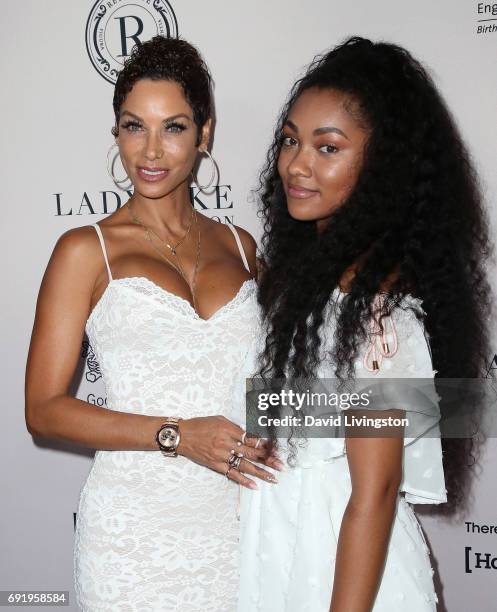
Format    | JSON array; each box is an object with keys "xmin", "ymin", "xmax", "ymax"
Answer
[{"xmin": 258, "ymin": 37, "xmax": 491, "ymax": 513}]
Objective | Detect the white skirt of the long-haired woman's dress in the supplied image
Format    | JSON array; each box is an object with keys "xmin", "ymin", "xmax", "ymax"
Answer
[{"xmin": 238, "ymin": 440, "xmax": 445, "ymax": 612}]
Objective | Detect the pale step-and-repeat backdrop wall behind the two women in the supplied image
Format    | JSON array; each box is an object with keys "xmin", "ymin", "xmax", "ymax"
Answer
[{"xmin": 0, "ymin": 0, "xmax": 497, "ymax": 612}]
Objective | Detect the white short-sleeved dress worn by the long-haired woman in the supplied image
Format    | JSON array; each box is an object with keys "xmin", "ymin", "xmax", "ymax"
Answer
[{"xmin": 237, "ymin": 289, "xmax": 447, "ymax": 612}]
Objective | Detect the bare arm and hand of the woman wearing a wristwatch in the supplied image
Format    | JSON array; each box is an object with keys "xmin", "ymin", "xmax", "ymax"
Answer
[{"xmin": 25, "ymin": 227, "xmax": 280, "ymax": 486}]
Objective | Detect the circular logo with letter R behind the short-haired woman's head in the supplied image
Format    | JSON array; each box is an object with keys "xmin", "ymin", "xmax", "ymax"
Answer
[{"xmin": 86, "ymin": 0, "xmax": 178, "ymax": 84}]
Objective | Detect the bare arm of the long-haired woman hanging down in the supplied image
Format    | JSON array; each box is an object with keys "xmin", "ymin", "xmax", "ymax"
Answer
[{"xmin": 330, "ymin": 410, "xmax": 403, "ymax": 612}]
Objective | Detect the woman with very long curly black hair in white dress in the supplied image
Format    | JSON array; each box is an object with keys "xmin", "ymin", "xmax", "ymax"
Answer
[{"xmin": 239, "ymin": 37, "xmax": 490, "ymax": 612}]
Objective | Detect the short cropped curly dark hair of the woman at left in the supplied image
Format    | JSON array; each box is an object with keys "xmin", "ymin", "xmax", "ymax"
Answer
[{"xmin": 112, "ymin": 36, "xmax": 212, "ymax": 144}]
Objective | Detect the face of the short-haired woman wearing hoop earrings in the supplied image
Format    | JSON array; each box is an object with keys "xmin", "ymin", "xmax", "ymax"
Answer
[{"xmin": 116, "ymin": 79, "xmax": 210, "ymax": 198}]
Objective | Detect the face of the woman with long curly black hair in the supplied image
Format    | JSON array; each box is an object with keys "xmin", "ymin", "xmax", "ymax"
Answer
[{"xmin": 278, "ymin": 88, "xmax": 369, "ymax": 227}]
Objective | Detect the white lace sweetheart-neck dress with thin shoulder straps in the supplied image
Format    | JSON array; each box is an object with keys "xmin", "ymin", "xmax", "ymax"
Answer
[{"xmin": 74, "ymin": 225, "xmax": 257, "ymax": 612}]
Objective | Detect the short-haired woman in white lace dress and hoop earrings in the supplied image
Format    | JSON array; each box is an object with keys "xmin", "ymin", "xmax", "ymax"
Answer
[{"xmin": 26, "ymin": 36, "xmax": 282, "ymax": 612}]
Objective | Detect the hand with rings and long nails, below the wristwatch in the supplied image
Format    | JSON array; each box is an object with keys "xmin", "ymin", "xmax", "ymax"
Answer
[{"xmin": 177, "ymin": 415, "xmax": 283, "ymax": 489}]
